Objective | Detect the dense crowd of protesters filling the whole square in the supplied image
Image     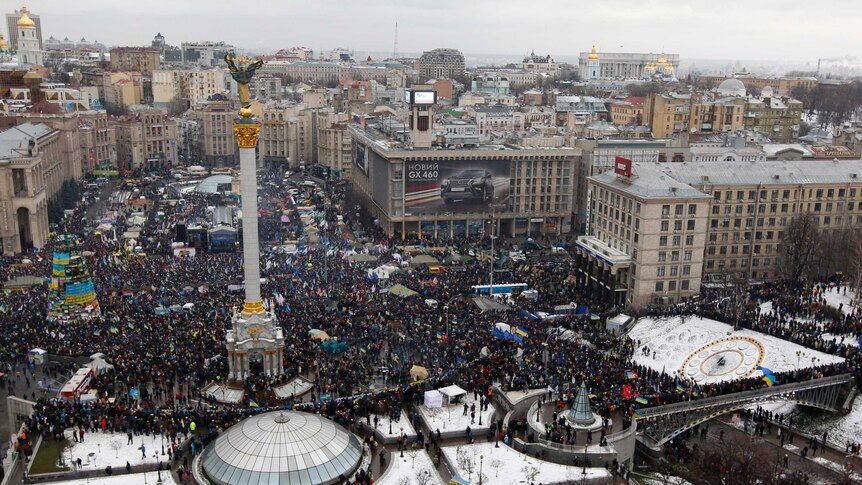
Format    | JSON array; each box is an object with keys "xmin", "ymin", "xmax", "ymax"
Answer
[{"xmin": 0, "ymin": 166, "xmax": 860, "ymax": 480}]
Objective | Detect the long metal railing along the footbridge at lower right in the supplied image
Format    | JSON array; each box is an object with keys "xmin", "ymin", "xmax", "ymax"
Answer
[{"xmin": 639, "ymin": 374, "xmax": 853, "ymax": 418}]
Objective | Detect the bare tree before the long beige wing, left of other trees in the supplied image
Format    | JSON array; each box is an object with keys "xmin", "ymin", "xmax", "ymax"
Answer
[{"xmin": 779, "ymin": 213, "xmax": 820, "ymax": 286}]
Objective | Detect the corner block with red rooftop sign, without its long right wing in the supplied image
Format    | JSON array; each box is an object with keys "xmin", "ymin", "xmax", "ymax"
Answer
[{"xmin": 576, "ymin": 164, "xmax": 710, "ymax": 307}]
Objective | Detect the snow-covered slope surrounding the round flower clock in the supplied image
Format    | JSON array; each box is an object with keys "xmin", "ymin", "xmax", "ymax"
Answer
[{"xmin": 629, "ymin": 316, "xmax": 843, "ymax": 383}]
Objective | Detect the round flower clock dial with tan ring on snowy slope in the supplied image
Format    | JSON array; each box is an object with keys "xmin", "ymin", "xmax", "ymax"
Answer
[{"xmin": 680, "ymin": 337, "xmax": 766, "ymax": 384}]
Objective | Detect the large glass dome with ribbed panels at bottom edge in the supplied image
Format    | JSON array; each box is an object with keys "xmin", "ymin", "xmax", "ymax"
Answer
[{"xmin": 201, "ymin": 411, "xmax": 362, "ymax": 485}]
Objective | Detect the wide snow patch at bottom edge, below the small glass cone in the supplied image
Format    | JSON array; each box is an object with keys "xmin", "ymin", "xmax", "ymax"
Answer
[{"xmin": 443, "ymin": 443, "xmax": 611, "ymax": 485}]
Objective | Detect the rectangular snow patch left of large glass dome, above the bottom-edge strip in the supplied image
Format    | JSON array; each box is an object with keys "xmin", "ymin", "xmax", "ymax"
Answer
[{"xmin": 64, "ymin": 428, "xmax": 168, "ymax": 468}]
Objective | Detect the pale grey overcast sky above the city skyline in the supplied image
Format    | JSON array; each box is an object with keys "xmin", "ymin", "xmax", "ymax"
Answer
[{"xmin": 23, "ymin": 0, "xmax": 862, "ymax": 63}]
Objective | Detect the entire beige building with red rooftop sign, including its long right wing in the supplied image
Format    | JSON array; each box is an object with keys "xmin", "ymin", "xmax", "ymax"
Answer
[{"xmin": 579, "ymin": 160, "xmax": 862, "ymax": 306}]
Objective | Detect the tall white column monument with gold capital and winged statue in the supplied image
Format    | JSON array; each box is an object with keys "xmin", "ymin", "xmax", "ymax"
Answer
[{"xmin": 225, "ymin": 56, "xmax": 284, "ymax": 381}]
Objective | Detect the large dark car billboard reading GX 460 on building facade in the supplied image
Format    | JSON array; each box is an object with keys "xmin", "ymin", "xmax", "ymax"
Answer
[{"xmin": 404, "ymin": 160, "xmax": 511, "ymax": 214}]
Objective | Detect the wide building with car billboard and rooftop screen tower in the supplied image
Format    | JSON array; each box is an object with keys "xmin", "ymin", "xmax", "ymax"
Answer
[{"xmin": 349, "ymin": 94, "xmax": 580, "ymax": 237}]
